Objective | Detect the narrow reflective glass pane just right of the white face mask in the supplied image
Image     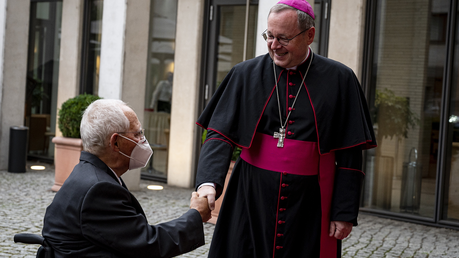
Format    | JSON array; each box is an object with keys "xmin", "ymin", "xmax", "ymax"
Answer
[{"xmin": 142, "ymin": 0, "xmax": 177, "ymax": 180}]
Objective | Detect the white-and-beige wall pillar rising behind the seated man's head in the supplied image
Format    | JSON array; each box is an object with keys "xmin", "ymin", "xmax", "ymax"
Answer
[{"xmin": 98, "ymin": 0, "xmax": 150, "ymax": 190}]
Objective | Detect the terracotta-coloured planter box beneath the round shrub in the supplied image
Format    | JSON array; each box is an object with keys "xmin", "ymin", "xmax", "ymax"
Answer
[{"xmin": 51, "ymin": 137, "xmax": 83, "ymax": 192}]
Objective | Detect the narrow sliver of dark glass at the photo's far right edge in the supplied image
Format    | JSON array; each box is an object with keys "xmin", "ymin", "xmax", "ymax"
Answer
[{"xmin": 442, "ymin": 4, "xmax": 459, "ymax": 222}]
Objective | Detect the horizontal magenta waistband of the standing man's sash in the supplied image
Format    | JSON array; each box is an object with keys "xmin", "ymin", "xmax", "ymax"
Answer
[{"xmin": 241, "ymin": 133, "xmax": 320, "ymax": 176}]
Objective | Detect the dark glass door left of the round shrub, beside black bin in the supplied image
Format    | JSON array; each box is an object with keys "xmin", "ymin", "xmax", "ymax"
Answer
[{"xmin": 24, "ymin": 1, "xmax": 62, "ymax": 161}]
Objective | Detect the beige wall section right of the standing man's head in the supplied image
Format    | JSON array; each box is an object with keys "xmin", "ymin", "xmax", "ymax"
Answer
[{"xmin": 328, "ymin": 0, "xmax": 365, "ymax": 77}]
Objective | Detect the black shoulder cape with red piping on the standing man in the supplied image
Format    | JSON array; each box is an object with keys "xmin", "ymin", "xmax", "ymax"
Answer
[{"xmin": 197, "ymin": 54, "xmax": 376, "ymax": 154}]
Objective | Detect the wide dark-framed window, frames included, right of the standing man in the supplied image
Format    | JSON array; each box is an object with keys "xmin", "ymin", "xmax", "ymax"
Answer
[{"xmin": 363, "ymin": 0, "xmax": 459, "ymax": 226}]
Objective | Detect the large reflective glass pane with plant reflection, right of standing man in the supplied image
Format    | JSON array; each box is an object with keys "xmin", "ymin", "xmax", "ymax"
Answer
[{"xmin": 364, "ymin": 0, "xmax": 449, "ymax": 218}]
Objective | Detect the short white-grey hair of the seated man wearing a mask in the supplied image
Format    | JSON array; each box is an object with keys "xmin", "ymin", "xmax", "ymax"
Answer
[{"xmin": 80, "ymin": 99, "xmax": 130, "ymax": 156}]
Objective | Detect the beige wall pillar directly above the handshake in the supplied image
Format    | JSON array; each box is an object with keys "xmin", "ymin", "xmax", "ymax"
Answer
[{"xmin": 167, "ymin": 0, "xmax": 204, "ymax": 187}]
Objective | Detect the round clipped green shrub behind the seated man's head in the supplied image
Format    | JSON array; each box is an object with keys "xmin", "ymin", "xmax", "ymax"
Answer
[{"xmin": 57, "ymin": 93, "xmax": 100, "ymax": 138}]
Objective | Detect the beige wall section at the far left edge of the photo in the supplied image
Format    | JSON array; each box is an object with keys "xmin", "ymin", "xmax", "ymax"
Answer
[{"xmin": 0, "ymin": 0, "xmax": 30, "ymax": 170}]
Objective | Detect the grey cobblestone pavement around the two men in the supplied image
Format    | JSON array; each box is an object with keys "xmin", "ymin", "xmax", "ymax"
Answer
[{"xmin": 0, "ymin": 164, "xmax": 459, "ymax": 258}]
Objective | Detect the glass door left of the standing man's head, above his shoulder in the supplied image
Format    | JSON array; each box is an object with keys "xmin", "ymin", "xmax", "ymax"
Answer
[{"xmin": 204, "ymin": 0, "xmax": 258, "ymax": 104}]
